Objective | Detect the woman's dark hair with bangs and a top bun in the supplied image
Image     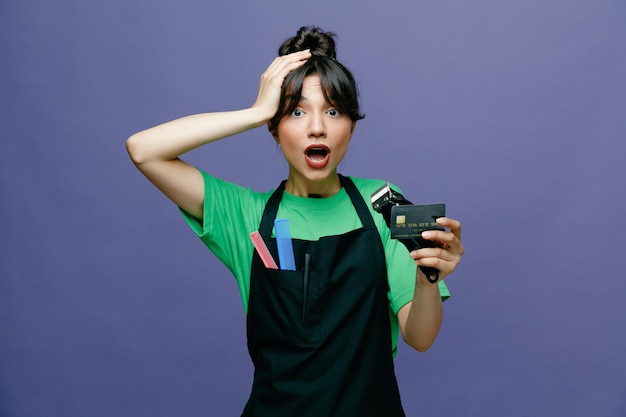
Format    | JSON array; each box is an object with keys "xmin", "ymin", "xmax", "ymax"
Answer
[{"xmin": 268, "ymin": 26, "xmax": 365, "ymax": 133}]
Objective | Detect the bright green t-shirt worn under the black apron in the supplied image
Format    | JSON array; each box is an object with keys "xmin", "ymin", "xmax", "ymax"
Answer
[{"xmin": 182, "ymin": 171, "xmax": 450, "ymax": 355}]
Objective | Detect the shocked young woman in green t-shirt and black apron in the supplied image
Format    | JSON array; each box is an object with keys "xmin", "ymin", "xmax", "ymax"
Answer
[{"xmin": 127, "ymin": 27, "xmax": 463, "ymax": 417}]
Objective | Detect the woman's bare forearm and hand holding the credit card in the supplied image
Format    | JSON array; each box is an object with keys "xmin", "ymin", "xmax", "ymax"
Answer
[{"xmin": 398, "ymin": 217, "xmax": 464, "ymax": 352}]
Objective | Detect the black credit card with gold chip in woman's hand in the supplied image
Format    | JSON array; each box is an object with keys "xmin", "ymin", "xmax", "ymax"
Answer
[{"xmin": 389, "ymin": 203, "xmax": 446, "ymax": 239}]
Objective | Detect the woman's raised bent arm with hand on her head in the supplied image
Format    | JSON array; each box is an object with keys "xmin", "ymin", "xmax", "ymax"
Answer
[{"xmin": 126, "ymin": 50, "xmax": 310, "ymax": 219}]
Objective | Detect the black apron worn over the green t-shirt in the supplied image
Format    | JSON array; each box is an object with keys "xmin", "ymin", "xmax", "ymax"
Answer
[{"xmin": 242, "ymin": 175, "xmax": 404, "ymax": 417}]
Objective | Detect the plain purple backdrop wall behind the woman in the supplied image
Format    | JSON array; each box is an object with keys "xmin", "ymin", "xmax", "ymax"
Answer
[{"xmin": 0, "ymin": 0, "xmax": 626, "ymax": 417}]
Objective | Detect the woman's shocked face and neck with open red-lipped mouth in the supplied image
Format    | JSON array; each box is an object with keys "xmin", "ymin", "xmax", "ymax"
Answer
[{"xmin": 275, "ymin": 75, "xmax": 355, "ymax": 197}]
